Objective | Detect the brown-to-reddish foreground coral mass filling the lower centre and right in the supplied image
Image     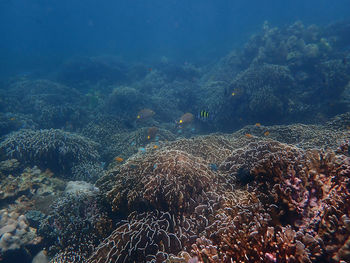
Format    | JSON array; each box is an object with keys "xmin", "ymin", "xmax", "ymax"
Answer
[{"xmin": 80, "ymin": 126, "xmax": 350, "ymax": 262}]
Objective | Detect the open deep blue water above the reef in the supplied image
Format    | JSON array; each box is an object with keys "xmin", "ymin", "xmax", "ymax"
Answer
[{"xmin": 0, "ymin": 0, "xmax": 350, "ymax": 74}]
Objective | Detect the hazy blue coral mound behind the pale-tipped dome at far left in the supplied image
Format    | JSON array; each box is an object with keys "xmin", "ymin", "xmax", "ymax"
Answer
[{"xmin": 4, "ymin": 80, "xmax": 89, "ymax": 128}]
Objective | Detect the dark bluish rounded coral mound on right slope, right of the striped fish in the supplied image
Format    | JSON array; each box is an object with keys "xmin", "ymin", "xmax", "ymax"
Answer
[{"xmin": 219, "ymin": 64, "xmax": 296, "ymax": 126}]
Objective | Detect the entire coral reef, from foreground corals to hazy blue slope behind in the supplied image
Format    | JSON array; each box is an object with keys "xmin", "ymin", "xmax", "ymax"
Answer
[{"xmin": 0, "ymin": 22, "xmax": 350, "ymax": 263}]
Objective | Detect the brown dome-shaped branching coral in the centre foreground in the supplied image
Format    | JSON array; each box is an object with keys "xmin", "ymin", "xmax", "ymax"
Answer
[{"xmin": 101, "ymin": 150, "xmax": 224, "ymax": 216}]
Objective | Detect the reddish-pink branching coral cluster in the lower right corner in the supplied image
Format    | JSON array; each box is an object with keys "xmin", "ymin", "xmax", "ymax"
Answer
[{"xmin": 185, "ymin": 139, "xmax": 350, "ymax": 262}]
